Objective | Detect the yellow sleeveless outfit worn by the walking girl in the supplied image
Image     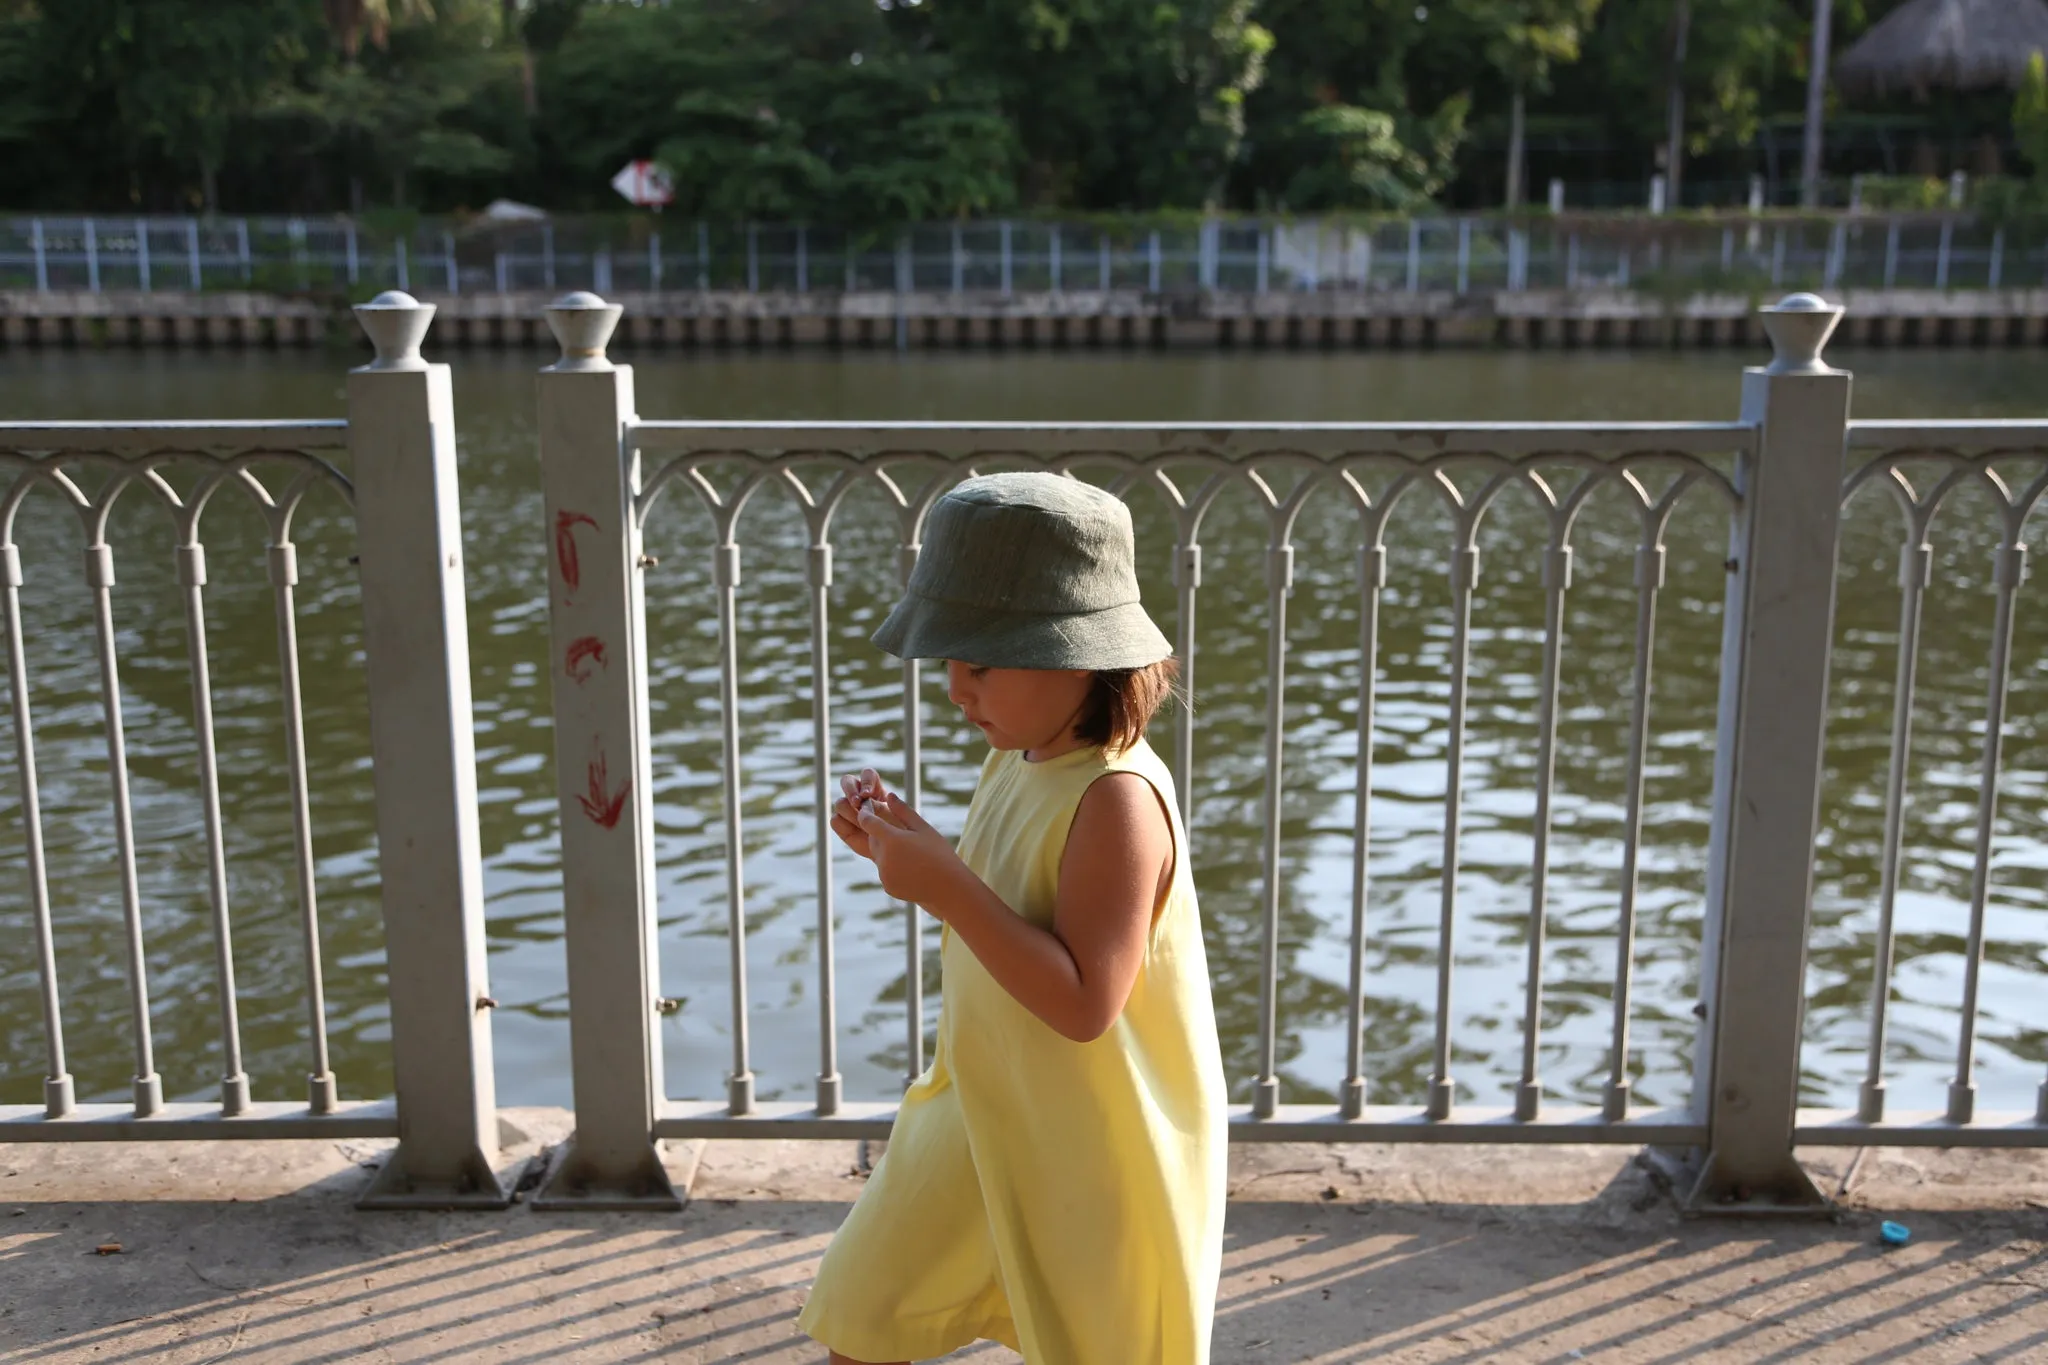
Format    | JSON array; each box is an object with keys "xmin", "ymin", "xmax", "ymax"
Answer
[{"xmin": 797, "ymin": 741, "xmax": 1227, "ymax": 1365}]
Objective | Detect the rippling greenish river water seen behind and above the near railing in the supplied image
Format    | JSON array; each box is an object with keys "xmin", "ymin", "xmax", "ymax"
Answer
[{"xmin": 0, "ymin": 352, "xmax": 2048, "ymax": 1109}]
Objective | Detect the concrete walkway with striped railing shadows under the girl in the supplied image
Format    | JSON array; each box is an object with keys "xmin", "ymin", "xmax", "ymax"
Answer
[{"xmin": 0, "ymin": 1109, "xmax": 2048, "ymax": 1365}]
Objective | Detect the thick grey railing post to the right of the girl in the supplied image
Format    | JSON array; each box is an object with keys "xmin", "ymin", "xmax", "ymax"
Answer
[{"xmin": 1688, "ymin": 295, "xmax": 1849, "ymax": 1212}]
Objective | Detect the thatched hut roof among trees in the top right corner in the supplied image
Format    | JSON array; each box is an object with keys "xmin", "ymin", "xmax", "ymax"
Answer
[{"xmin": 1833, "ymin": 0, "xmax": 2048, "ymax": 96}]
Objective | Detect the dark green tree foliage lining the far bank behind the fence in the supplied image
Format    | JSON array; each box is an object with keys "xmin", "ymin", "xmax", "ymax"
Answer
[{"xmin": 0, "ymin": 0, "xmax": 2042, "ymax": 215}]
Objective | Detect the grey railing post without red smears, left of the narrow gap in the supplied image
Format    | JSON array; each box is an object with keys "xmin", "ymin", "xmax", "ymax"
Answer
[{"xmin": 348, "ymin": 291, "xmax": 510, "ymax": 1209}]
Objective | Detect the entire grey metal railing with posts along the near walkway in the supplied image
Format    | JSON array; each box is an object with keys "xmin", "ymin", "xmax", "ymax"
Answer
[{"xmin": 0, "ymin": 286, "xmax": 2048, "ymax": 1207}]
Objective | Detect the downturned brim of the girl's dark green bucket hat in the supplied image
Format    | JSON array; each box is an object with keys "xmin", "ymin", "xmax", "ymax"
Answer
[{"xmin": 872, "ymin": 591, "xmax": 1174, "ymax": 669}]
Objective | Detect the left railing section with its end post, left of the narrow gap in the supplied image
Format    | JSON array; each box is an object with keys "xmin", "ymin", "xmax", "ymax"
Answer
[{"xmin": 0, "ymin": 299, "xmax": 506, "ymax": 1207}]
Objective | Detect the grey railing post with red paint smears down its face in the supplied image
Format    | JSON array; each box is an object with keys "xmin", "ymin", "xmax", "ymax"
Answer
[{"xmin": 532, "ymin": 293, "xmax": 682, "ymax": 1209}]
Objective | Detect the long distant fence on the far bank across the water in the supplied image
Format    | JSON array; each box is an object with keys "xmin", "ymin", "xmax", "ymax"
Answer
[{"xmin": 0, "ymin": 213, "xmax": 2048, "ymax": 297}]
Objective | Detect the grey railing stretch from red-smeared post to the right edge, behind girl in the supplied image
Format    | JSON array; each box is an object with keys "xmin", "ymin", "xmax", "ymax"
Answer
[{"xmin": 524, "ymin": 295, "xmax": 2048, "ymax": 1207}]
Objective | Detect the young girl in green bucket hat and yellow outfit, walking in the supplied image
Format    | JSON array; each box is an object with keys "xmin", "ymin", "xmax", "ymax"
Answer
[{"xmin": 797, "ymin": 475, "xmax": 1227, "ymax": 1365}]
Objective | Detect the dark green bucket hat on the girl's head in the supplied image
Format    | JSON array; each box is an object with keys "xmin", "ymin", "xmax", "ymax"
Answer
[{"xmin": 874, "ymin": 473, "xmax": 1174, "ymax": 669}]
